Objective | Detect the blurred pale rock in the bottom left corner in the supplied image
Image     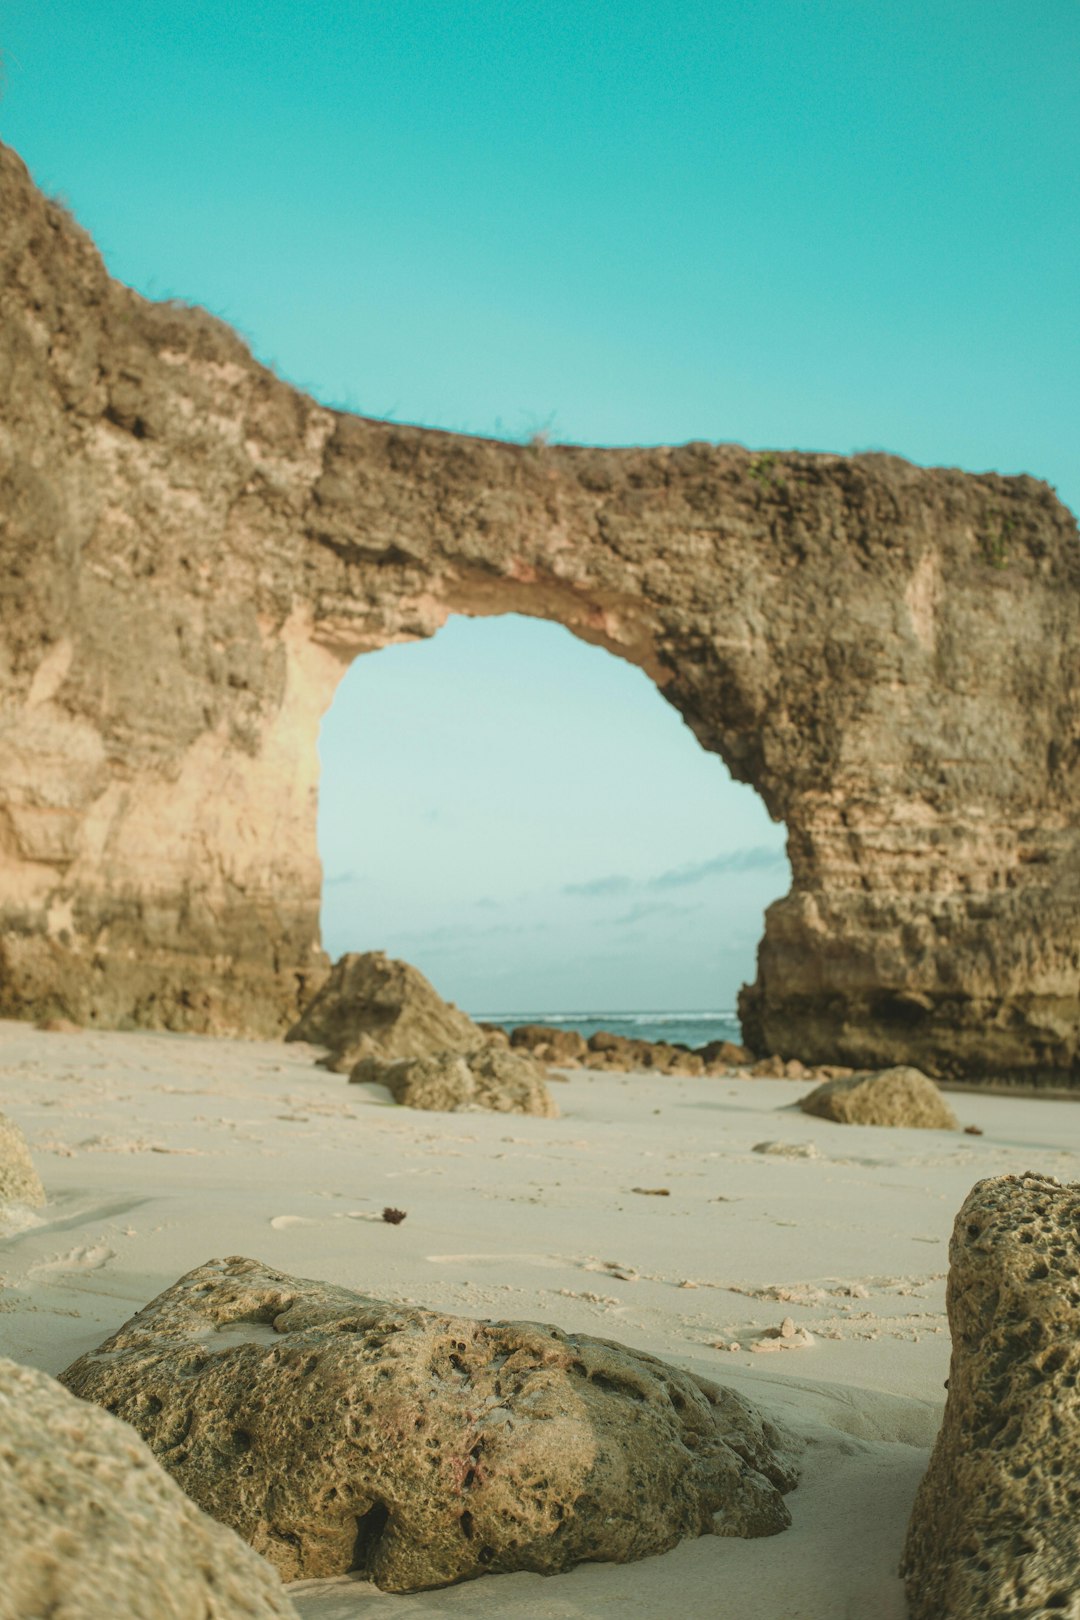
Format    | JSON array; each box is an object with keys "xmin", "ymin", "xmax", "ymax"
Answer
[{"xmin": 0, "ymin": 1361, "xmax": 296, "ymax": 1620}]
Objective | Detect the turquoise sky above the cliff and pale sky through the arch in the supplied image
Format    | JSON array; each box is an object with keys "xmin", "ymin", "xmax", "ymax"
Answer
[{"xmin": 0, "ymin": 0, "xmax": 1080, "ymax": 1009}]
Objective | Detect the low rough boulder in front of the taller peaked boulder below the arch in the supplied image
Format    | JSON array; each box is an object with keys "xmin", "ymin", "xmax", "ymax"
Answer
[{"xmin": 350, "ymin": 1045, "xmax": 559, "ymax": 1119}]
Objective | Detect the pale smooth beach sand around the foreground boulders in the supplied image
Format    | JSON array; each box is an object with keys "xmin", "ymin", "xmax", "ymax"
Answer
[{"xmin": 0, "ymin": 1022, "xmax": 1080, "ymax": 1620}]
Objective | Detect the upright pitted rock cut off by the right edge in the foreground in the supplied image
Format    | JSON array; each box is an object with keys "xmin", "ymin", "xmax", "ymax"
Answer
[{"xmin": 902, "ymin": 1175, "xmax": 1080, "ymax": 1620}]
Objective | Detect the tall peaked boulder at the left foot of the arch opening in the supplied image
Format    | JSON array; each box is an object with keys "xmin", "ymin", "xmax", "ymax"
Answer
[{"xmin": 285, "ymin": 951, "xmax": 484, "ymax": 1074}]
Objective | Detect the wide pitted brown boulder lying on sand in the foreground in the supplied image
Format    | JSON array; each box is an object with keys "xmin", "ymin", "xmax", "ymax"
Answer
[{"xmin": 62, "ymin": 1259, "xmax": 795, "ymax": 1592}]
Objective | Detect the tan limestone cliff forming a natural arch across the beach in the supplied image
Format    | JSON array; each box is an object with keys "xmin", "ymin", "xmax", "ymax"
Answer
[{"xmin": 0, "ymin": 139, "xmax": 1080, "ymax": 1079}]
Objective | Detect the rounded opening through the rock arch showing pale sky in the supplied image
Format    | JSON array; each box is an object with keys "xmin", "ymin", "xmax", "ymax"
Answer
[{"xmin": 317, "ymin": 612, "xmax": 790, "ymax": 1037}]
